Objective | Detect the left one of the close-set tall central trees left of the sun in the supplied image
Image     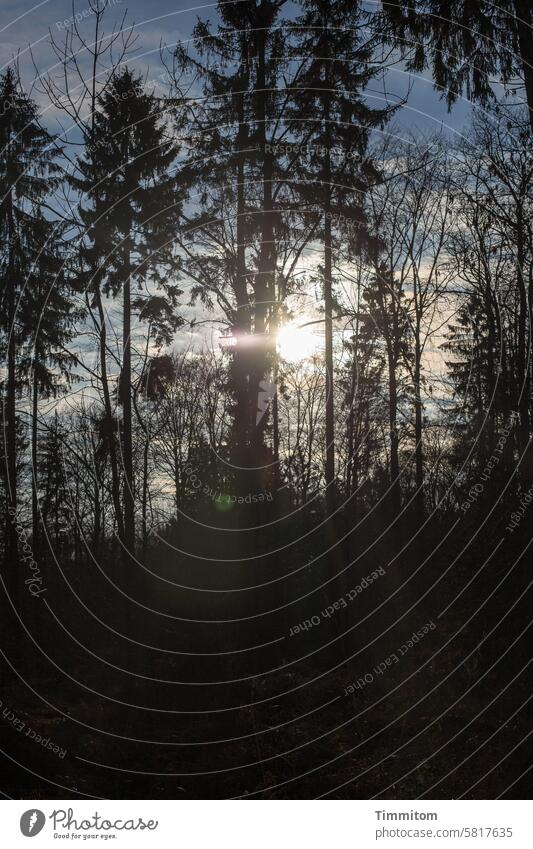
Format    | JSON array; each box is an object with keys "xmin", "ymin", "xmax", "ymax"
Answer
[{"xmin": 172, "ymin": 22, "xmax": 257, "ymax": 476}]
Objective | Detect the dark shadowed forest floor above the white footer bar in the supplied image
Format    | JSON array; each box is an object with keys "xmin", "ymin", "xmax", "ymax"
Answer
[{"xmin": 0, "ymin": 506, "xmax": 533, "ymax": 799}]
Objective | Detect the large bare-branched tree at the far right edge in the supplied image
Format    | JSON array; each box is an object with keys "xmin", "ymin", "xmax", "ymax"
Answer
[{"xmin": 447, "ymin": 110, "xmax": 533, "ymax": 476}]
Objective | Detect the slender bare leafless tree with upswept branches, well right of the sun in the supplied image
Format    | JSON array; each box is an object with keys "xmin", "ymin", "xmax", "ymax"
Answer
[{"xmin": 369, "ymin": 136, "xmax": 452, "ymax": 521}]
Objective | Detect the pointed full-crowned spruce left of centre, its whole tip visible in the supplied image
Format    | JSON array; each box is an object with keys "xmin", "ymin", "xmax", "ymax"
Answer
[{"xmin": 73, "ymin": 68, "xmax": 181, "ymax": 559}]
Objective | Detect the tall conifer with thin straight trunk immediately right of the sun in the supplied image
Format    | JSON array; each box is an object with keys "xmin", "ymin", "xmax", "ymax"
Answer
[{"xmin": 284, "ymin": 0, "xmax": 390, "ymax": 512}]
